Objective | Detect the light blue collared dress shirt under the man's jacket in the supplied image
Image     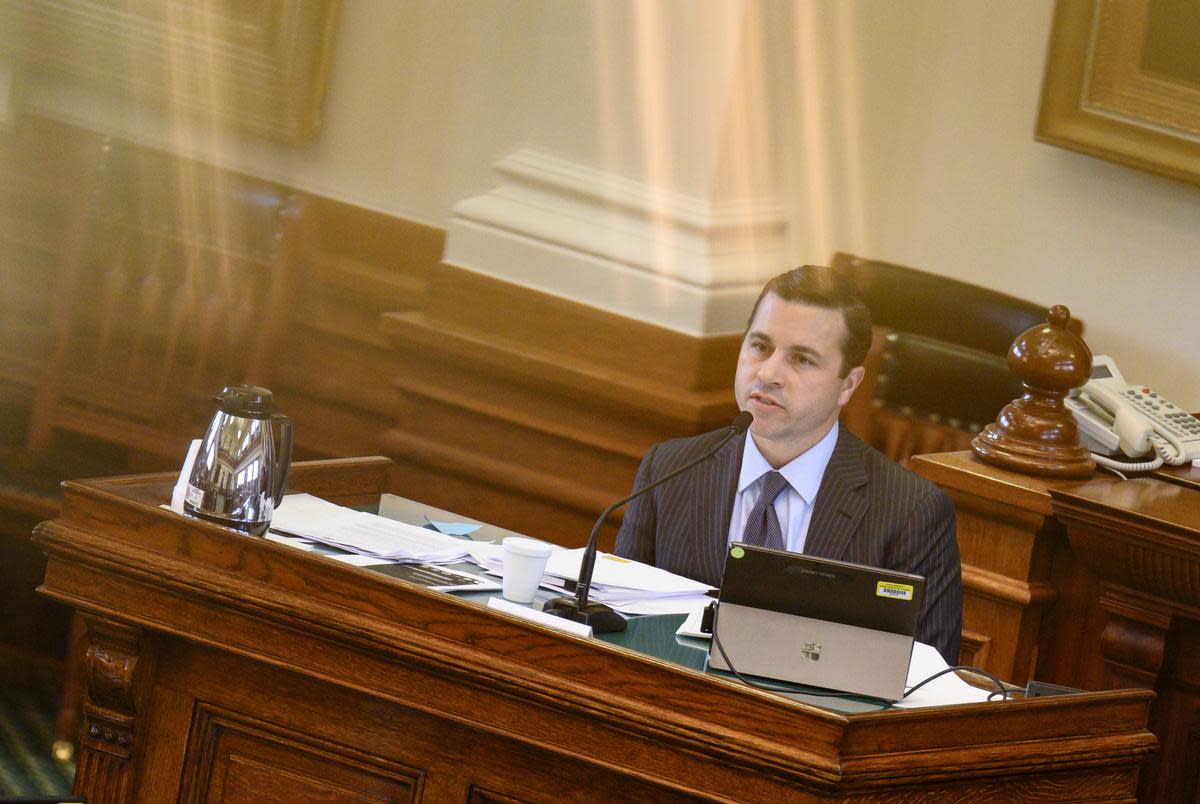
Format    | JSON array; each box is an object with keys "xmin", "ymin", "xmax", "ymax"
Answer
[{"xmin": 730, "ymin": 421, "xmax": 839, "ymax": 553}]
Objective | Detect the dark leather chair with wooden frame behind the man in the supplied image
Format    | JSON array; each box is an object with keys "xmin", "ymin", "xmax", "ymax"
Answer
[{"xmin": 833, "ymin": 253, "xmax": 1082, "ymax": 463}]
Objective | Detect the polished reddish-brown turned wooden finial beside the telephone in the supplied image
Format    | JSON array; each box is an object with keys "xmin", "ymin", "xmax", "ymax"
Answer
[{"xmin": 971, "ymin": 305, "xmax": 1096, "ymax": 478}]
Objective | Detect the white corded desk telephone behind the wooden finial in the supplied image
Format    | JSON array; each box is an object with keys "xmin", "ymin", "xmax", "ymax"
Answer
[{"xmin": 1064, "ymin": 354, "xmax": 1200, "ymax": 472}]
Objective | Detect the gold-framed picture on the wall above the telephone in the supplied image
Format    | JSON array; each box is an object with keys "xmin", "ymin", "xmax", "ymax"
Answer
[{"xmin": 1037, "ymin": 0, "xmax": 1200, "ymax": 184}]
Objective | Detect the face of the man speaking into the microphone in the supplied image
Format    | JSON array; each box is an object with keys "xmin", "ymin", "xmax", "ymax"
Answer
[{"xmin": 733, "ymin": 293, "xmax": 863, "ymax": 468}]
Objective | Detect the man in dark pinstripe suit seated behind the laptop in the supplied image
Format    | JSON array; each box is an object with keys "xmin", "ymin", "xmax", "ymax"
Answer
[{"xmin": 617, "ymin": 265, "xmax": 962, "ymax": 665}]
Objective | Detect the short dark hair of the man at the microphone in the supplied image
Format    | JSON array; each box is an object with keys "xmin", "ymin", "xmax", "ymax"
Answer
[{"xmin": 746, "ymin": 265, "xmax": 871, "ymax": 377}]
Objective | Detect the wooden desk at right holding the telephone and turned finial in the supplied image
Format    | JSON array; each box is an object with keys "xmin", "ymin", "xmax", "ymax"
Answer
[{"xmin": 912, "ymin": 452, "xmax": 1200, "ymax": 804}]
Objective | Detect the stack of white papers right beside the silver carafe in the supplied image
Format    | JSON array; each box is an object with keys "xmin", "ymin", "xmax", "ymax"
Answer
[{"xmin": 271, "ymin": 494, "xmax": 469, "ymax": 564}]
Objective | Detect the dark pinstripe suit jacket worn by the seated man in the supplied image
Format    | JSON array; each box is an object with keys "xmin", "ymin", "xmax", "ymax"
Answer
[{"xmin": 617, "ymin": 427, "xmax": 962, "ymax": 665}]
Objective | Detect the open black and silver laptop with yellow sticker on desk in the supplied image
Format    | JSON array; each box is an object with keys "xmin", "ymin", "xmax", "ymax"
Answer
[{"xmin": 708, "ymin": 542, "xmax": 925, "ymax": 701}]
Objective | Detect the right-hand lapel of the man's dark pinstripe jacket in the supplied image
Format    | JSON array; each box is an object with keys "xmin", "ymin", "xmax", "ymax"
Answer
[{"xmin": 804, "ymin": 425, "xmax": 868, "ymax": 559}]
